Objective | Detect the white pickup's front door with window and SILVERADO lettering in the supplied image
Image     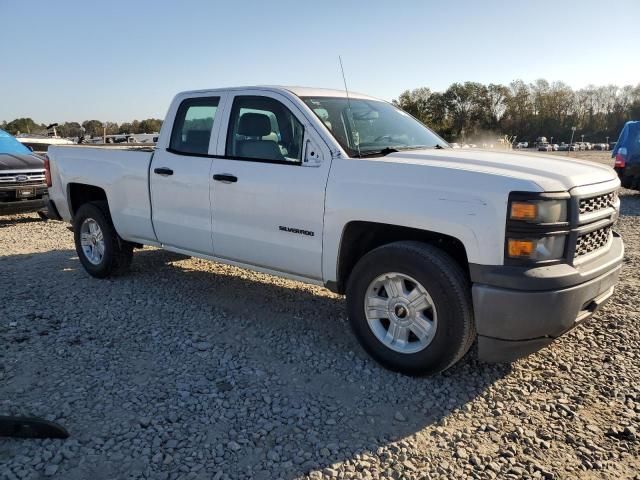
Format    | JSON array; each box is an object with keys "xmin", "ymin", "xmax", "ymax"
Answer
[{"xmin": 212, "ymin": 94, "xmax": 330, "ymax": 279}]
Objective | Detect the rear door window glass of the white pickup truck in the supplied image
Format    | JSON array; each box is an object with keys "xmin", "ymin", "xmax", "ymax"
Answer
[{"xmin": 169, "ymin": 97, "xmax": 220, "ymax": 154}]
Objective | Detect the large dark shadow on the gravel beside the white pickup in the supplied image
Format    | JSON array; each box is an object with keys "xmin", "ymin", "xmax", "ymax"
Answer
[{"xmin": 0, "ymin": 249, "xmax": 510, "ymax": 479}]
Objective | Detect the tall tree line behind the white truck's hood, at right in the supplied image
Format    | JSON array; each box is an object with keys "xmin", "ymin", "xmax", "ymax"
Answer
[{"xmin": 393, "ymin": 79, "xmax": 640, "ymax": 143}]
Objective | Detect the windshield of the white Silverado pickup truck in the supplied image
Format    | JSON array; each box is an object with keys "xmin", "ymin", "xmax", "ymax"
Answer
[{"xmin": 301, "ymin": 97, "xmax": 448, "ymax": 157}]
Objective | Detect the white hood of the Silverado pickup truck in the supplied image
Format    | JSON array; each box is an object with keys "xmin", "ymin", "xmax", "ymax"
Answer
[{"xmin": 381, "ymin": 148, "xmax": 617, "ymax": 191}]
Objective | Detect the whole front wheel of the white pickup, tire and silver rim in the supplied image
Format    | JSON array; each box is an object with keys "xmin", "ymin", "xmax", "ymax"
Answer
[{"xmin": 347, "ymin": 242, "xmax": 475, "ymax": 375}]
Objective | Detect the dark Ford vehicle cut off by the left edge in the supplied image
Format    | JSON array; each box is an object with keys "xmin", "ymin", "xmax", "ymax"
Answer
[{"xmin": 0, "ymin": 130, "xmax": 47, "ymax": 218}]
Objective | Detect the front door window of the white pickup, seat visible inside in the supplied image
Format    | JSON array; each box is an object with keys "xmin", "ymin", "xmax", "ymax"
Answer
[{"xmin": 226, "ymin": 96, "xmax": 304, "ymax": 163}]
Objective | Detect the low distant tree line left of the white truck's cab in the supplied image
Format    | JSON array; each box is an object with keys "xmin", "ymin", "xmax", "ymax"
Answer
[{"xmin": 0, "ymin": 118, "xmax": 162, "ymax": 138}]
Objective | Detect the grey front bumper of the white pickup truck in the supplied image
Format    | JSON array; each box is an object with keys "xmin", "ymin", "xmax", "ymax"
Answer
[{"xmin": 472, "ymin": 234, "xmax": 624, "ymax": 362}]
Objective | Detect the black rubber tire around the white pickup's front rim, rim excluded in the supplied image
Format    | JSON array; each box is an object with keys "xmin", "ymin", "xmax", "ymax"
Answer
[{"xmin": 347, "ymin": 241, "xmax": 476, "ymax": 375}]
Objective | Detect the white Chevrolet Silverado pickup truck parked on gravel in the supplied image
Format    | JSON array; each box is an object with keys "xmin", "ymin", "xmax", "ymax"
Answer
[{"xmin": 46, "ymin": 87, "xmax": 623, "ymax": 374}]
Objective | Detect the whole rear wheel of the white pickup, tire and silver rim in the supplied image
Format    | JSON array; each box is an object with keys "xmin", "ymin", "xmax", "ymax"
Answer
[{"xmin": 73, "ymin": 202, "xmax": 133, "ymax": 278}]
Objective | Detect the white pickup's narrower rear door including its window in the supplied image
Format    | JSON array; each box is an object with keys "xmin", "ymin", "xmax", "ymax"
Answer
[{"xmin": 149, "ymin": 95, "xmax": 224, "ymax": 251}]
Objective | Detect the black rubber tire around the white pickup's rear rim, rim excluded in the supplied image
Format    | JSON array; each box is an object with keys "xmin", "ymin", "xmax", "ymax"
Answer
[{"xmin": 73, "ymin": 202, "xmax": 133, "ymax": 278}]
